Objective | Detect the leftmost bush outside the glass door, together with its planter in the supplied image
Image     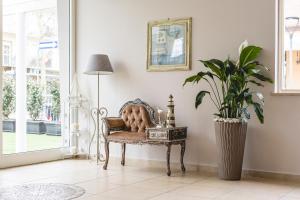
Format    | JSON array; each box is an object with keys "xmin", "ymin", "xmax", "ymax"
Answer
[{"xmin": 2, "ymin": 78, "xmax": 16, "ymax": 132}]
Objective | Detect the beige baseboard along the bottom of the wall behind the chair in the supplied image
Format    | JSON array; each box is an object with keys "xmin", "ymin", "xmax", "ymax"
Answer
[{"xmin": 82, "ymin": 157, "xmax": 300, "ymax": 182}]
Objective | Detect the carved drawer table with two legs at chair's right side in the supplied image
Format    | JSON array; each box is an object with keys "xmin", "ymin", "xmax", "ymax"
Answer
[{"xmin": 146, "ymin": 127, "xmax": 187, "ymax": 176}]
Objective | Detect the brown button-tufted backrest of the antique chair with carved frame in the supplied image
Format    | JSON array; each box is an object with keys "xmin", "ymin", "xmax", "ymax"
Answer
[{"xmin": 120, "ymin": 99, "xmax": 155, "ymax": 132}]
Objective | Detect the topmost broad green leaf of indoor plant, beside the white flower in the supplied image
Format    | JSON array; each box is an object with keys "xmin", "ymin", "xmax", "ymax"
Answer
[{"xmin": 240, "ymin": 46, "xmax": 262, "ymax": 67}]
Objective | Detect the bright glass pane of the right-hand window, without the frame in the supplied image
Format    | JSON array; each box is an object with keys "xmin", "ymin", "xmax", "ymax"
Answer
[{"xmin": 281, "ymin": 0, "xmax": 300, "ymax": 90}]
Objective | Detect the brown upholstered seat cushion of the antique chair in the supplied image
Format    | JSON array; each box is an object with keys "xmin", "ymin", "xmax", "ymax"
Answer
[{"xmin": 107, "ymin": 131, "xmax": 146, "ymax": 143}]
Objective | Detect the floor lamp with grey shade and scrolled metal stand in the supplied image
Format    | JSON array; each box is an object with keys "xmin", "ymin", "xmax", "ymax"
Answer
[{"xmin": 85, "ymin": 54, "xmax": 113, "ymax": 164}]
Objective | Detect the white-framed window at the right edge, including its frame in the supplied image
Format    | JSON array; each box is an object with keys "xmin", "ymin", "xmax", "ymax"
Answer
[{"xmin": 276, "ymin": 0, "xmax": 300, "ymax": 93}]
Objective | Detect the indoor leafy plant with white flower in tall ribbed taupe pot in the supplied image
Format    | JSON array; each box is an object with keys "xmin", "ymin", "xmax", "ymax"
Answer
[{"xmin": 184, "ymin": 41, "xmax": 273, "ymax": 180}]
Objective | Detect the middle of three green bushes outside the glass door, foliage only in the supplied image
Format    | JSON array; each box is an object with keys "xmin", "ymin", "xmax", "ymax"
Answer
[{"xmin": 27, "ymin": 81, "xmax": 44, "ymax": 121}]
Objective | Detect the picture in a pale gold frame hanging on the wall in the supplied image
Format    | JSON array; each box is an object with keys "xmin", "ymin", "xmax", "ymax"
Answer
[{"xmin": 147, "ymin": 18, "xmax": 192, "ymax": 71}]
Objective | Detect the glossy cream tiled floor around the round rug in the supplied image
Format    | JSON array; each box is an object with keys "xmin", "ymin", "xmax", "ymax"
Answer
[{"xmin": 0, "ymin": 160, "xmax": 300, "ymax": 200}]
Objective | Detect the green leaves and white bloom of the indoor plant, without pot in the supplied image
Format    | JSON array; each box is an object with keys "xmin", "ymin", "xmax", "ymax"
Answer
[{"xmin": 184, "ymin": 42, "xmax": 273, "ymax": 123}]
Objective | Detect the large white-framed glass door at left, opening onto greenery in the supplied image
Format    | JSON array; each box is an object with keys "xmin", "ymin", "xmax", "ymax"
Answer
[{"xmin": 0, "ymin": 0, "xmax": 71, "ymax": 167}]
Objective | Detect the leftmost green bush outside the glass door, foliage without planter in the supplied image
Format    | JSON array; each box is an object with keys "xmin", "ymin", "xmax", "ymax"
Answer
[{"xmin": 2, "ymin": 78, "xmax": 16, "ymax": 119}]
